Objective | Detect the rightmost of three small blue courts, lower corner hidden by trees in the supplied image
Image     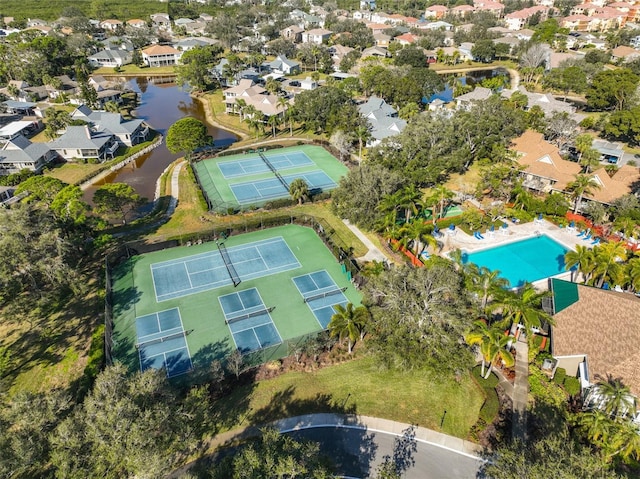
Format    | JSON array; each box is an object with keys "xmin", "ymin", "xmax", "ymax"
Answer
[{"xmin": 293, "ymin": 270, "xmax": 349, "ymax": 329}]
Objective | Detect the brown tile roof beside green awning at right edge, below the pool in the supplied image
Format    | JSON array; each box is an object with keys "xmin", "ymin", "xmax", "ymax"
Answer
[{"xmin": 552, "ymin": 285, "xmax": 640, "ymax": 396}]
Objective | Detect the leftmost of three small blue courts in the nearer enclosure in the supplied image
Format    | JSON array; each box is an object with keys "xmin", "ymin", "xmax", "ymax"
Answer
[{"xmin": 136, "ymin": 308, "xmax": 193, "ymax": 377}]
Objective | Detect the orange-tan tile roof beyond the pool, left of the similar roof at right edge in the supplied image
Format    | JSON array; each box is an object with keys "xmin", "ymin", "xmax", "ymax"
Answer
[{"xmin": 512, "ymin": 130, "xmax": 581, "ymax": 190}]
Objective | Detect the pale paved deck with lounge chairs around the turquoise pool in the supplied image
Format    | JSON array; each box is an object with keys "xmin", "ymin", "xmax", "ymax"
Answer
[{"xmin": 438, "ymin": 220, "xmax": 594, "ymax": 289}]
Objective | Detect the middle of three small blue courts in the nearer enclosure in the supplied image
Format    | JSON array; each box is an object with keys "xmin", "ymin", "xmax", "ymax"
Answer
[{"xmin": 218, "ymin": 288, "xmax": 282, "ymax": 353}]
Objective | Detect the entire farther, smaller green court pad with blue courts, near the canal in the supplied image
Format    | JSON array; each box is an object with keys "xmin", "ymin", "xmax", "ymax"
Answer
[{"xmin": 194, "ymin": 145, "xmax": 348, "ymax": 212}]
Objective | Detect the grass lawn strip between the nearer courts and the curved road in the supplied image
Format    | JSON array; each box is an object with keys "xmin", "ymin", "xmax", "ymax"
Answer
[{"xmin": 212, "ymin": 356, "xmax": 484, "ymax": 438}]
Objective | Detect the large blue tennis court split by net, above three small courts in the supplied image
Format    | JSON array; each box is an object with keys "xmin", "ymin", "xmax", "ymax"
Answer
[{"xmin": 151, "ymin": 236, "xmax": 300, "ymax": 302}]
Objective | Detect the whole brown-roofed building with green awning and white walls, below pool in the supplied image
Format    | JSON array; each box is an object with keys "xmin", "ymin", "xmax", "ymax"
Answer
[{"xmin": 551, "ymin": 279, "xmax": 640, "ymax": 414}]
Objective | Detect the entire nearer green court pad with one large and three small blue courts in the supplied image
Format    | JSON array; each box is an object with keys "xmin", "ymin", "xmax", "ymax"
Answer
[{"xmin": 111, "ymin": 225, "xmax": 362, "ymax": 377}]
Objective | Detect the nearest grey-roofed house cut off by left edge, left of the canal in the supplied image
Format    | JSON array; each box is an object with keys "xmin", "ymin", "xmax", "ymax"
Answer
[{"xmin": 0, "ymin": 135, "xmax": 57, "ymax": 175}]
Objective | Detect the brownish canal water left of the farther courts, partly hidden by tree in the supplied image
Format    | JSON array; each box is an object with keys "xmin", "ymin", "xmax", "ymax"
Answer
[{"xmin": 85, "ymin": 77, "xmax": 238, "ymax": 201}]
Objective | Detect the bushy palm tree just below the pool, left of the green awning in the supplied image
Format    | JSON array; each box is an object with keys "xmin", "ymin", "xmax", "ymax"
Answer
[{"xmin": 491, "ymin": 283, "xmax": 555, "ymax": 339}]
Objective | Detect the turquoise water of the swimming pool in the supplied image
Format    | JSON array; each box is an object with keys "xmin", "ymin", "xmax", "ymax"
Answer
[{"xmin": 462, "ymin": 235, "xmax": 569, "ymax": 288}]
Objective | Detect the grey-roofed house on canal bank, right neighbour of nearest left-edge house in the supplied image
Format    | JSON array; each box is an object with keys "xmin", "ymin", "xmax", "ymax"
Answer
[{"xmin": 49, "ymin": 125, "xmax": 119, "ymax": 161}]
